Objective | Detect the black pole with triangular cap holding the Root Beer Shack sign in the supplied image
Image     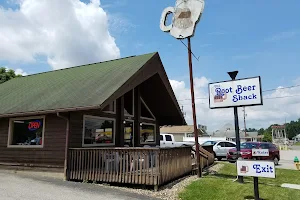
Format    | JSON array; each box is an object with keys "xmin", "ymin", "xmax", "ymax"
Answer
[{"xmin": 228, "ymin": 71, "xmax": 244, "ymax": 183}]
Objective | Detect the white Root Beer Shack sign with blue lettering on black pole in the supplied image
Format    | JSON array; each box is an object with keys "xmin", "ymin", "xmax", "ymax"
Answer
[{"xmin": 209, "ymin": 77, "xmax": 263, "ymax": 108}]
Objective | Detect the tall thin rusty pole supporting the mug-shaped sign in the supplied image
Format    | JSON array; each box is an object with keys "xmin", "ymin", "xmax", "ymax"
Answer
[{"xmin": 188, "ymin": 37, "xmax": 202, "ymax": 178}]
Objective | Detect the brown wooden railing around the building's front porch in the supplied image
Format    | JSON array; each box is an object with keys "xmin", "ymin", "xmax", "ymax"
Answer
[{"xmin": 67, "ymin": 147, "xmax": 209, "ymax": 186}]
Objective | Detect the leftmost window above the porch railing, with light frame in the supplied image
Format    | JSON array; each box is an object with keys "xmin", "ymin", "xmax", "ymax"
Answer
[{"xmin": 83, "ymin": 116, "xmax": 115, "ymax": 146}]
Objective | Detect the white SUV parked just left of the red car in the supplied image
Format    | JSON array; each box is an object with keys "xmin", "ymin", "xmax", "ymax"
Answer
[{"xmin": 202, "ymin": 140, "xmax": 236, "ymax": 160}]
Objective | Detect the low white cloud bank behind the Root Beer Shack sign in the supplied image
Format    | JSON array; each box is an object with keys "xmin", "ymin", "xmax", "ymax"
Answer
[{"xmin": 170, "ymin": 77, "xmax": 300, "ymax": 131}]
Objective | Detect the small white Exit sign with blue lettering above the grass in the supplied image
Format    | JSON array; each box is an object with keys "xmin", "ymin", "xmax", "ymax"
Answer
[{"xmin": 237, "ymin": 160, "xmax": 275, "ymax": 178}]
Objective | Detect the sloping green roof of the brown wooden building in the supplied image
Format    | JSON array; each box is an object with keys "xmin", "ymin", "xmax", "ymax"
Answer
[{"xmin": 0, "ymin": 53, "xmax": 155, "ymax": 116}]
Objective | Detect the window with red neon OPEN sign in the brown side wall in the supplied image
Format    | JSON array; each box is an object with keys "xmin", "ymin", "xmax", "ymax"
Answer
[{"xmin": 8, "ymin": 116, "xmax": 45, "ymax": 147}]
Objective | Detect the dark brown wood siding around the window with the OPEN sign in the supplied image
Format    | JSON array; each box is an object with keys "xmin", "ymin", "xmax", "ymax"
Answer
[{"xmin": 0, "ymin": 114, "xmax": 67, "ymax": 167}]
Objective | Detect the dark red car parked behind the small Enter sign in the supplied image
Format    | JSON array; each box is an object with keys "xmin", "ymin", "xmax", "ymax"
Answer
[{"xmin": 227, "ymin": 142, "xmax": 280, "ymax": 165}]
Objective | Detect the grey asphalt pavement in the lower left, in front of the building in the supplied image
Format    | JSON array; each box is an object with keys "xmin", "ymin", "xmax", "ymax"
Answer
[{"xmin": 0, "ymin": 170, "xmax": 155, "ymax": 200}]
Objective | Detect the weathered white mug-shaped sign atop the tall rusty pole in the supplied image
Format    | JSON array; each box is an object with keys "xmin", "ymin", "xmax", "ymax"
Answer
[{"xmin": 160, "ymin": 0, "xmax": 204, "ymax": 39}]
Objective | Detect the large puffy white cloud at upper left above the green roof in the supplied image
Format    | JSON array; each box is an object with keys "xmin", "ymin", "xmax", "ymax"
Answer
[{"xmin": 0, "ymin": 0, "xmax": 120, "ymax": 69}]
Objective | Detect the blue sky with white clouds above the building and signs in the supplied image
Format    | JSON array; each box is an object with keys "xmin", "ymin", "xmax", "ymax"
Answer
[{"xmin": 0, "ymin": 0, "xmax": 300, "ymax": 131}]
